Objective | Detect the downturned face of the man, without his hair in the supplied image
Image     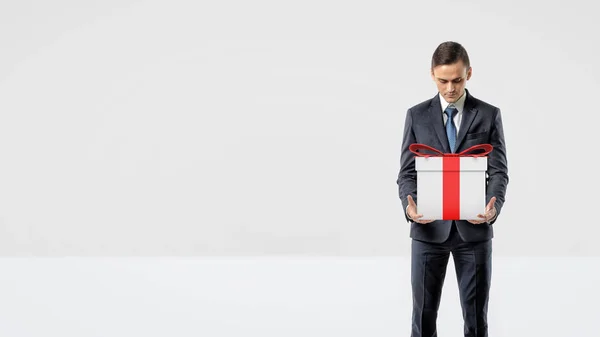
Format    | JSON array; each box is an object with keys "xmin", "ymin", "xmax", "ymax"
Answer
[{"xmin": 431, "ymin": 61, "xmax": 471, "ymax": 103}]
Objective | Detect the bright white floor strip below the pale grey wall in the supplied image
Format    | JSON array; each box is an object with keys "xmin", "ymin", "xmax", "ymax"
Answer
[{"xmin": 0, "ymin": 257, "xmax": 600, "ymax": 337}]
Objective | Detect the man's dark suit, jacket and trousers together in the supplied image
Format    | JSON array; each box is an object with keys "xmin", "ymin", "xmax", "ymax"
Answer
[{"xmin": 397, "ymin": 89, "xmax": 508, "ymax": 337}]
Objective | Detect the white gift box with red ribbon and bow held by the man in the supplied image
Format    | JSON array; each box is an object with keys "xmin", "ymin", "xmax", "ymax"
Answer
[{"xmin": 409, "ymin": 144, "xmax": 493, "ymax": 220}]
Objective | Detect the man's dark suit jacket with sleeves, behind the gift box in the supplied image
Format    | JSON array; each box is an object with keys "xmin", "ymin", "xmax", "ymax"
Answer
[{"xmin": 396, "ymin": 89, "xmax": 508, "ymax": 242}]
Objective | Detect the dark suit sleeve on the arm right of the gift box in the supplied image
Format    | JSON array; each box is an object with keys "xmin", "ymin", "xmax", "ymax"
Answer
[{"xmin": 486, "ymin": 109, "xmax": 508, "ymax": 225}]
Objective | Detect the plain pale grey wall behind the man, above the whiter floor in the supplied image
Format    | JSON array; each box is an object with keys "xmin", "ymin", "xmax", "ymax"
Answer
[{"xmin": 0, "ymin": 0, "xmax": 600, "ymax": 256}]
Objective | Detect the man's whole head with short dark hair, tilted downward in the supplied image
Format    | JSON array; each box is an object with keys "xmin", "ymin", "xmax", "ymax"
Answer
[{"xmin": 431, "ymin": 41, "xmax": 472, "ymax": 103}]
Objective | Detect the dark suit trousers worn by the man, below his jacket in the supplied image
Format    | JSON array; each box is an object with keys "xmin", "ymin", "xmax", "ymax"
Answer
[{"xmin": 411, "ymin": 221, "xmax": 492, "ymax": 337}]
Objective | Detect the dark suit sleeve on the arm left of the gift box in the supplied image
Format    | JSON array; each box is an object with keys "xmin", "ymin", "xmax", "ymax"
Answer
[{"xmin": 396, "ymin": 109, "xmax": 417, "ymax": 222}]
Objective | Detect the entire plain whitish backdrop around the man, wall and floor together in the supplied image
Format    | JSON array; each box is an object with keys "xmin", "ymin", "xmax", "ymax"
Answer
[{"xmin": 0, "ymin": 0, "xmax": 600, "ymax": 337}]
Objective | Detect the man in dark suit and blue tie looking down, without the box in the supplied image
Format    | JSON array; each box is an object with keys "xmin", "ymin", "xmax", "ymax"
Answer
[{"xmin": 397, "ymin": 42, "xmax": 508, "ymax": 337}]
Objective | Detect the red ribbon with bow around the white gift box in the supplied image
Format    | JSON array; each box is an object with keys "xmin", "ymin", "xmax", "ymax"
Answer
[{"xmin": 409, "ymin": 144, "xmax": 494, "ymax": 220}]
